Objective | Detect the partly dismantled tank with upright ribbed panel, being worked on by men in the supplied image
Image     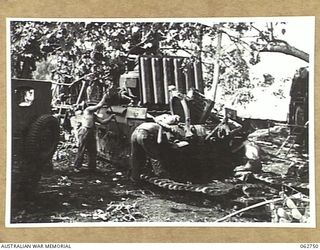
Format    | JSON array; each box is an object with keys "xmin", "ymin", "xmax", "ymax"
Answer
[{"xmin": 96, "ymin": 56, "xmax": 252, "ymax": 183}]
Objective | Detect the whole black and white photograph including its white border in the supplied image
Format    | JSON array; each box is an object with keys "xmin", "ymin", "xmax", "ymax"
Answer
[{"xmin": 6, "ymin": 16, "xmax": 316, "ymax": 227}]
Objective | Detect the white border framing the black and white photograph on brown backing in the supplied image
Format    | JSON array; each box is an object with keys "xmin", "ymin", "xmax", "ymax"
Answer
[{"xmin": 5, "ymin": 16, "xmax": 316, "ymax": 228}]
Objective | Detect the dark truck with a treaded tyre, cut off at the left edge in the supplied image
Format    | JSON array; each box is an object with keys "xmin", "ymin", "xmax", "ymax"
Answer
[{"xmin": 11, "ymin": 79, "xmax": 60, "ymax": 198}]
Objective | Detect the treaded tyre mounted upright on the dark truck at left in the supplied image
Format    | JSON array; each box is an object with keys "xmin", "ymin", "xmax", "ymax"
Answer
[{"xmin": 25, "ymin": 115, "xmax": 59, "ymax": 163}]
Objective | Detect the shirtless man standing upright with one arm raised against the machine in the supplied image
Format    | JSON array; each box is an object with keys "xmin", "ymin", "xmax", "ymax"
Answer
[{"xmin": 74, "ymin": 93, "xmax": 115, "ymax": 171}]
